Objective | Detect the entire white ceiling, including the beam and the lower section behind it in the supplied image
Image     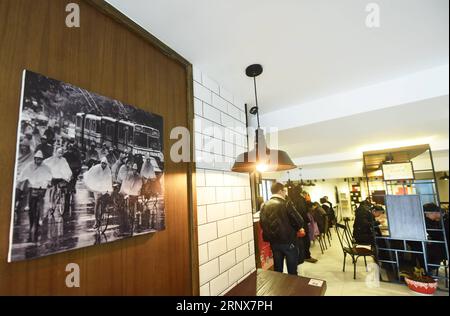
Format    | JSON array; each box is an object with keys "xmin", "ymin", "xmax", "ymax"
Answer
[{"xmin": 107, "ymin": 0, "xmax": 449, "ymax": 177}]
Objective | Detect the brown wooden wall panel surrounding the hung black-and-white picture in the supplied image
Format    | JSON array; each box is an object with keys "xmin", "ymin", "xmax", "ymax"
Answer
[{"xmin": 0, "ymin": 0, "xmax": 198, "ymax": 295}]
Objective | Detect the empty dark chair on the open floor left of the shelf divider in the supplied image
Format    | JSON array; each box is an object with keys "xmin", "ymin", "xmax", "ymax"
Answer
[{"xmin": 334, "ymin": 223, "xmax": 376, "ymax": 279}]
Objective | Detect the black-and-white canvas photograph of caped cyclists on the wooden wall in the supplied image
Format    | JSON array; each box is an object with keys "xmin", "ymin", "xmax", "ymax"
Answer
[{"xmin": 8, "ymin": 70, "xmax": 165, "ymax": 262}]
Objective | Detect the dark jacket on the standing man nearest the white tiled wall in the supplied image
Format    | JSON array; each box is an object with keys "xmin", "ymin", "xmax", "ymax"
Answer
[{"xmin": 260, "ymin": 196, "xmax": 304, "ymax": 244}]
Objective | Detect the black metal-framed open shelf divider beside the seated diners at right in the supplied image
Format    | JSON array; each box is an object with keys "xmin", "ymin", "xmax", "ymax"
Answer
[{"xmin": 364, "ymin": 145, "xmax": 449, "ymax": 288}]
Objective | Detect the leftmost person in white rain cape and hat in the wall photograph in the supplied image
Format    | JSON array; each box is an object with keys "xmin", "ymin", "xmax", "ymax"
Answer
[{"xmin": 17, "ymin": 150, "xmax": 52, "ymax": 242}]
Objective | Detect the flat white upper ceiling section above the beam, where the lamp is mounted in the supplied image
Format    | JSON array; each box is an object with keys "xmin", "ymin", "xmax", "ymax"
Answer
[{"xmin": 108, "ymin": 0, "xmax": 449, "ymax": 113}]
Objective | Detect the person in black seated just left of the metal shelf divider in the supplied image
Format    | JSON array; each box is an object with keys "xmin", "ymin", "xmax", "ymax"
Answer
[{"xmin": 353, "ymin": 205, "xmax": 384, "ymax": 245}]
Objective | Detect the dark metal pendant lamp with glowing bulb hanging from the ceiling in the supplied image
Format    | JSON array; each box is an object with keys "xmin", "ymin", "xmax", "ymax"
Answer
[{"xmin": 231, "ymin": 64, "xmax": 297, "ymax": 173}]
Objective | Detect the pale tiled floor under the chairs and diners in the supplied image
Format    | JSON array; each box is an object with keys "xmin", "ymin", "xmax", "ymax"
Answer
[{"xmin": 290, "ymin": 230, "xmax": 449, "ymax": 296}]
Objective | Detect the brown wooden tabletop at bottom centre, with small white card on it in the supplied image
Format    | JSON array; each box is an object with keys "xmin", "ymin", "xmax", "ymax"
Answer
[{"xmin": 225, "ymin": 269, "xmax": 327, "ymax": 296}]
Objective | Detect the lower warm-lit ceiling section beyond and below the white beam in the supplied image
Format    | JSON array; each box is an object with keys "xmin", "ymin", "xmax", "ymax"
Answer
[{"xmin": 278, "ymin": 95, "xmax": 449, "ymax": 158}]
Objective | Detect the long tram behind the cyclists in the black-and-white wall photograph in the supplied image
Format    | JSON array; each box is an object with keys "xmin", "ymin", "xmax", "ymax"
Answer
[{"xmin": 75, "ymin": 113, "xmax": 164, "ymax": 169}]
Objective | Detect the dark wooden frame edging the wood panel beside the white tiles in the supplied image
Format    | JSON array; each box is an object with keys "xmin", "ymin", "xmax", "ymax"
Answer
[{"xmin": 83, "ymin": 0, "xmax": 200, "ymax": 296}]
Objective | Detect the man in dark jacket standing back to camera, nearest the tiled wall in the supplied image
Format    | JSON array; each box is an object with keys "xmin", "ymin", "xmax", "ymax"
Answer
[{"xmin": 260, "ymin": 182, "xmax": 304, "ymax": 275}]
